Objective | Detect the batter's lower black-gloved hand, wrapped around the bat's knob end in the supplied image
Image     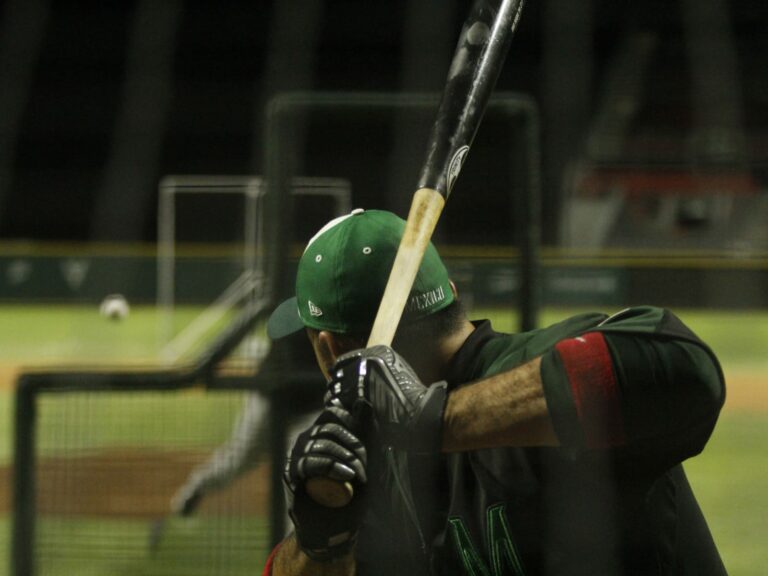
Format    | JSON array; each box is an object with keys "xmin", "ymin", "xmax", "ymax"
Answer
[{"xmin": 283, "ymin": 407, "xmax": 368, "ymax": 561}]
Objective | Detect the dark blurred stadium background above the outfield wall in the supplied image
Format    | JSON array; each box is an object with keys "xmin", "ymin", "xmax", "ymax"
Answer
[{"xmin": 0, "ymin": 0, "xmax": 768, "ymax": 244}]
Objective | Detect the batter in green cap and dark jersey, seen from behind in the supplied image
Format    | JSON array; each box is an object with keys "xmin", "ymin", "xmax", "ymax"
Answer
[{"xmin": 264, "ymin": 211, "xmax": 726, "ymax": 576}]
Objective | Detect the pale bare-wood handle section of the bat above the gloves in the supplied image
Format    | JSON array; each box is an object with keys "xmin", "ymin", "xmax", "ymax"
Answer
[{"xmin": 368, "ymin": 188, "xmax": 445, "ymax": 347}]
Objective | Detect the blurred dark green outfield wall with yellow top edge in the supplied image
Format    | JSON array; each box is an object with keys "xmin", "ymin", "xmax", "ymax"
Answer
[{"xmin": 0, "ymin": 247, "xmax": 768, "ymax": 309}]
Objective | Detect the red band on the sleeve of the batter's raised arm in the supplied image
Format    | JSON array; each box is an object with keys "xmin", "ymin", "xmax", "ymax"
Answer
[{"xmin": 555, "ymin": 332, "xmax": 625, "ymax": 448}]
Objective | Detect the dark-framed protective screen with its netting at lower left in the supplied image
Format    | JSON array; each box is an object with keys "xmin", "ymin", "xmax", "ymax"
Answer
[{"xmin": 12, "ymin": 312, "xmax": 322, "ymax": 576}]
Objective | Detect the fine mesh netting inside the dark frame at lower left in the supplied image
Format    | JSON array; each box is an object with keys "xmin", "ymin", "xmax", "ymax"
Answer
[{"xmin": 35, "ymin": 390, "xmax": 269, "ymax": 575}]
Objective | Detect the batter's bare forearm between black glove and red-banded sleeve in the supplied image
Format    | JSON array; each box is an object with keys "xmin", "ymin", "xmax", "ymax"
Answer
[{"xmin": 443, "ymin": 358, "xmax": 558, "ymax": 452}]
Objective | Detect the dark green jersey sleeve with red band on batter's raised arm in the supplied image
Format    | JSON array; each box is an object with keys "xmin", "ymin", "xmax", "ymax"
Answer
[{"xmin": 541, "ymin": 307, "xmax": 725, "ymax": 461}]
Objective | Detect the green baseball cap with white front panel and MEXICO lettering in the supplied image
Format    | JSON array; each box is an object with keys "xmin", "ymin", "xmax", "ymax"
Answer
[{"xmin": 267, "ymin": 208, "xmax": 454, "ymax": 340}]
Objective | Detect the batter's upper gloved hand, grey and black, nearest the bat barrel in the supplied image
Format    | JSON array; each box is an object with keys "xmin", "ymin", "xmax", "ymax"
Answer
[{"xmin": 326, "ymin": 346, "xmax": 447, "ymax": 454}]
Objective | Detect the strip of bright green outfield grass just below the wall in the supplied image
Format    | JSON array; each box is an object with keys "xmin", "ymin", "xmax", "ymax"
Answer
[{"xmin": 0, "ymin": 305, "xmax": 768, "ymax": 367}]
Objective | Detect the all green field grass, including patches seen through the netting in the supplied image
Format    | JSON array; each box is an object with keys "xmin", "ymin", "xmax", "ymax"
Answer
[{"xmin": 0, "ymin": 306, "xmax": 768, "ymax": 576}]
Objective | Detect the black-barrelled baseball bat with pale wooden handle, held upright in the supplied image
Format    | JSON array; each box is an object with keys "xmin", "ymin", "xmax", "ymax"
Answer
[{"xmin": 306, "ymin": 0, "xmax": 523, "ymax": 507}]
